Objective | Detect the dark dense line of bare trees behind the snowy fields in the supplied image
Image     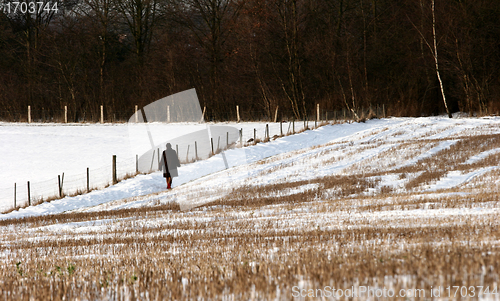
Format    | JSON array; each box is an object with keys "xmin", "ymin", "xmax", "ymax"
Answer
[{"xmin": 0, "ymin": 0, "xmax": 500, "ymax": 121}]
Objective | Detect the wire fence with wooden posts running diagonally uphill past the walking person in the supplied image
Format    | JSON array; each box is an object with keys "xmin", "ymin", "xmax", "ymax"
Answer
[{"xmin": 0, "ymin": 107, "xmax": 385, "ymax": 212}]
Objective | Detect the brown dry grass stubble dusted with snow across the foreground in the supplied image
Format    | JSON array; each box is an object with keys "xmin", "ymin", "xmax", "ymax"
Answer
[{"xmin": 0, "ymin": 127, "xmax": 500, "ymax": 300}]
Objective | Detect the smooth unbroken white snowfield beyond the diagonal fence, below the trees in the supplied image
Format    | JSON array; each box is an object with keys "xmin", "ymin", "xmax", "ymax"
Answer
[{"xmin": 0, "ymin": 122, "xmax": 304, "ymax": 211}]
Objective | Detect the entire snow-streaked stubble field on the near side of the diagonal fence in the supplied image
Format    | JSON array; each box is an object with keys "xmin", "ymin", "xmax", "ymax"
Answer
[{"xmin": 0, "ymin": 117, "xmax": 500, "ymax": 300}]
